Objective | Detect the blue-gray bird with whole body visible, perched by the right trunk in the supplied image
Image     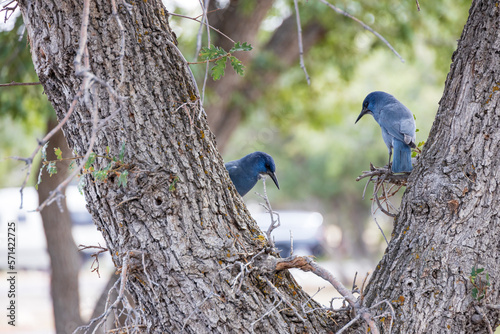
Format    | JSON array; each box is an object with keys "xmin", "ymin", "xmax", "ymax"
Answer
[{"xmin": 354, "ymin": 92, "xmax": 416, "ymax": 173}]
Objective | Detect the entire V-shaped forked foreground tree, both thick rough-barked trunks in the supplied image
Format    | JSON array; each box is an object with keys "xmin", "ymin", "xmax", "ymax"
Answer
[{"xmin": 20, "ymin": 0, "xmax": 500, "ymax": 333}]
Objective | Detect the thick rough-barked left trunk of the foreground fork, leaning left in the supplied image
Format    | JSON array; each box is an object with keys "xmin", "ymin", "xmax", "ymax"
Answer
[{"xmin": 19, "ymin": 0, "xmax": 335, "ymax": 333}]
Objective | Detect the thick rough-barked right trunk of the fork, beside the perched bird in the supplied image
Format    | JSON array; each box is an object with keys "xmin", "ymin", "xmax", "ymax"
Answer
[{"xmin": 365, "ymin": 0, "xmax": 500, "ymax": 333}]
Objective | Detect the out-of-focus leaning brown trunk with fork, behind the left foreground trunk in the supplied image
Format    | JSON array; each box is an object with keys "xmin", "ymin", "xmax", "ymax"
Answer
[{"xmin": 206, "ymin": 0, "xmax": 326, "ymax": 151}]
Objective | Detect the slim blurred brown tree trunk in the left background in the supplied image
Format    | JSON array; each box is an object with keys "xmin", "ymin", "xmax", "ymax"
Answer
[{"xmin": 38, "ymin": 119, "xmax": 83, "ymax": 334}]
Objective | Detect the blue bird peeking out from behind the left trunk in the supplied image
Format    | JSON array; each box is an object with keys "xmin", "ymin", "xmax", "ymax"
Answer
[{"xmin": 225, "ymin": 152, "xmax": 280, "ymax": 196}]
